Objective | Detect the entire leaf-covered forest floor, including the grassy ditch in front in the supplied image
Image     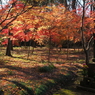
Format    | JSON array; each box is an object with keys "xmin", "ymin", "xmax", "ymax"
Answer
[{"xmin": 0, "ymin": 47, "xmax": 95, "ymax": 95}]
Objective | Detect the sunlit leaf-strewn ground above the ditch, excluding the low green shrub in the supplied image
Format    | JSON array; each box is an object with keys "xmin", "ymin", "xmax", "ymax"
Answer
[{"xmin": 0, "ymin": 47, "xmax": 93, "ymax": 95}]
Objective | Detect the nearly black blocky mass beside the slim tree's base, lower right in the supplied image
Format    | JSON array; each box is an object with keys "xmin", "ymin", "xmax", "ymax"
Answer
[{"xmin": 77, "ymin": 62, "xmax": 95, "ymax": 92}]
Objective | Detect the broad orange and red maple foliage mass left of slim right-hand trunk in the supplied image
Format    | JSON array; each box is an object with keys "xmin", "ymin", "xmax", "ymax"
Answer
[{"xmin": 1, "ymin": 4, "xmax": 93, "ymax": 44}]
